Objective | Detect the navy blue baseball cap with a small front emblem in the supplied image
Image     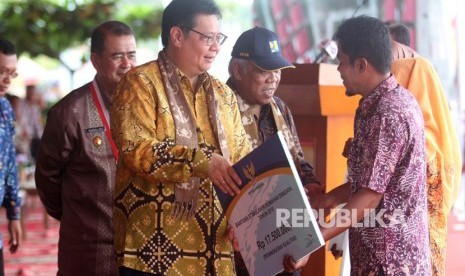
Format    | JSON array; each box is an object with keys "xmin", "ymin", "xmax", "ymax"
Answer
[{"xmin": 231, "ymin": 27, "xmax": 295, "ymax": 71}]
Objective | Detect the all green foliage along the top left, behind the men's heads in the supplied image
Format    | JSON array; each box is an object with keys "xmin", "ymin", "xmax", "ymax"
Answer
[{"xmin": 0, "ymin": 0, "xmax": 161, "ymax": 60}]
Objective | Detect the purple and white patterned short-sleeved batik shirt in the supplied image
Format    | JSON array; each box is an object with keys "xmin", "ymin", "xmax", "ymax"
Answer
[{"xmin": 348, "ymin": 76, "xmax": 431, "ymax": 276}]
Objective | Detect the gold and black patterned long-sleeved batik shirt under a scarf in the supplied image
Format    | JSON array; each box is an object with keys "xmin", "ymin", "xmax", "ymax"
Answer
[{"xmin": 111, "ymin": 61, "xmax": 250, "ymax": 275}]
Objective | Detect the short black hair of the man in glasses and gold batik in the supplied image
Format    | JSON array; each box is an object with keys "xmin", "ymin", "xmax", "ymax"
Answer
[{"xmin": 161, "ymin": 0, "xmax": 221, "ymax": 47}]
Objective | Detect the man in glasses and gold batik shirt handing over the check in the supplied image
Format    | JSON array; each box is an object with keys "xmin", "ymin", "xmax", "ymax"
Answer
[{"xmin": 111, "ymin": 0, "xmax": 250, "ymax": 276}]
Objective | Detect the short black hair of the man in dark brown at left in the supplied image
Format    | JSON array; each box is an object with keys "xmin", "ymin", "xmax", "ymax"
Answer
[{"xmin": 90, "ymin": 21, "xmax": 134, "ymax": 54}]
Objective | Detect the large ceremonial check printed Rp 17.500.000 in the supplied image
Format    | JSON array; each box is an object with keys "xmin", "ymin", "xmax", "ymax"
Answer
[{"xmin": 216, "ymin": 132, "xmax": 324, "ymax": 275}]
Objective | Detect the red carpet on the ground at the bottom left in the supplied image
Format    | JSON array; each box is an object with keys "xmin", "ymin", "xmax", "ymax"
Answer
[{"xmin": 0, "ymin": 196, "xmax": 59, "ymax": 276}]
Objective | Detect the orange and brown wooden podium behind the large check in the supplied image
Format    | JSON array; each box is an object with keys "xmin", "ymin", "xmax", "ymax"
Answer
[{"xmin": 276, "ymin": 63, "xmax": 360, "ymax": 276}]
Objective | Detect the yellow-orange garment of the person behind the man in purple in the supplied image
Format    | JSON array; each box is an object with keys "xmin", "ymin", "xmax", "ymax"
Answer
[{"xmin": 391, "ymin": 57, "xmax": 462, "ymax": 276}]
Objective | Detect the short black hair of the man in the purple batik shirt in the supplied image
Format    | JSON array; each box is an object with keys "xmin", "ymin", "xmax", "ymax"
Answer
[{"xmin": 334, "ymin": 15, "xmax": 392, "ymax": 74}]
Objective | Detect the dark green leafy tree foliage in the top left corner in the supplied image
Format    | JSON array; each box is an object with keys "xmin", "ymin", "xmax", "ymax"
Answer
[{"xmin": 0, "ymin": 0, "xmax": 114, "ymax": 58}]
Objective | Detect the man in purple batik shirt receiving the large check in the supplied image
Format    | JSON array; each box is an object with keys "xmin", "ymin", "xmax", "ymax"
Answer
[{"xmin": 284, "ymin": 16, "xmax": 431, "ymax": 276}]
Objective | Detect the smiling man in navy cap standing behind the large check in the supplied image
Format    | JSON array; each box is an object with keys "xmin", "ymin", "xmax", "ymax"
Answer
[{"xmin": 227, "ymin": 27, "xmax": 325, "ymax": 275}]
